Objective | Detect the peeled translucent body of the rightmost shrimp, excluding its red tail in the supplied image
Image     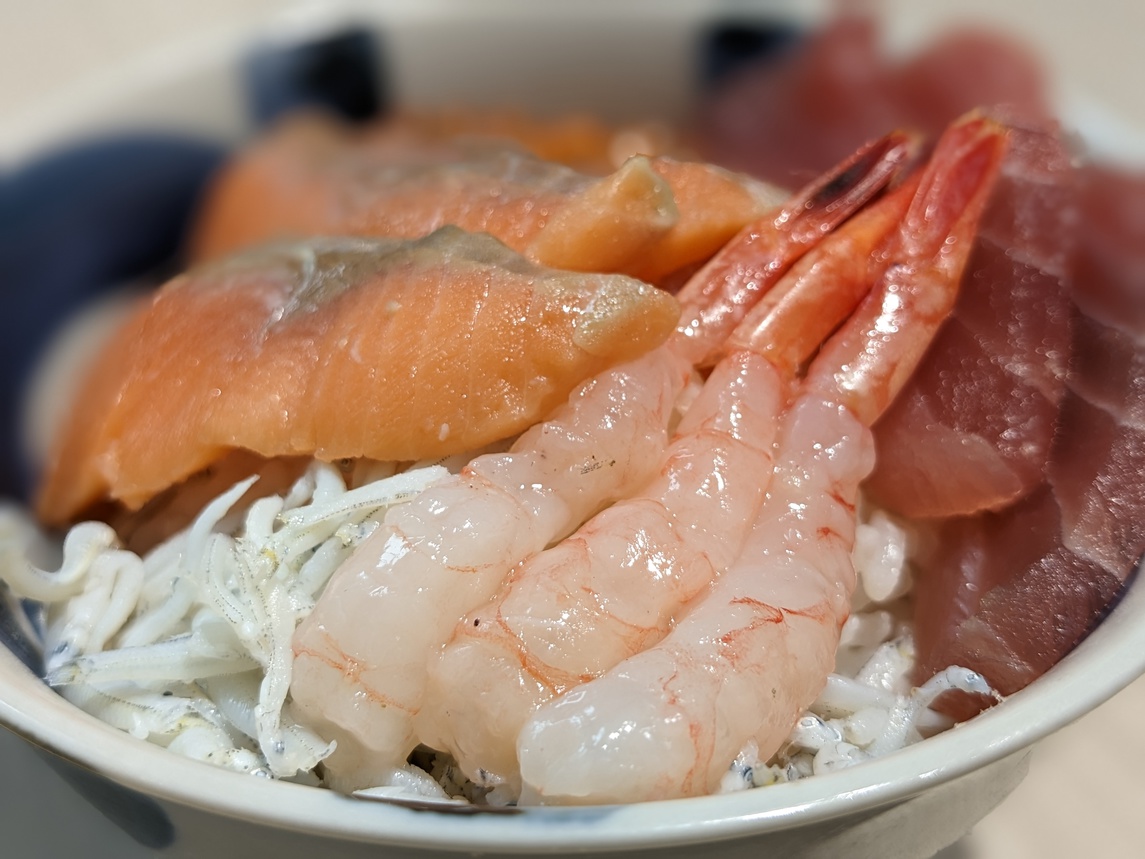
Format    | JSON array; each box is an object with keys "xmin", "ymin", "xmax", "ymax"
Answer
[{"xmin": 518, "ymin": 399, "xmax": 874, "ymax": 804}]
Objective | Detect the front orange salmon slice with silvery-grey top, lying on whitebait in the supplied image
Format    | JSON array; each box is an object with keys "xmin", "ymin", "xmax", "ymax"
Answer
[{"xmin": 38, "ymin": 228, "xmax": 679, "ymax": 525}]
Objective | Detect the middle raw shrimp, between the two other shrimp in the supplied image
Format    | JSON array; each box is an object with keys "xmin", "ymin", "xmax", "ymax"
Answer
[{"xmin": 416, "ymin": 156, "xmax": 917, "ymax": 790}]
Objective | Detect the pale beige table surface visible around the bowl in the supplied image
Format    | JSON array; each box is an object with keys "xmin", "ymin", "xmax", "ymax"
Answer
[{"xmin": 0, "ymin": 0, "xmax": 1145, "ymax": 859}]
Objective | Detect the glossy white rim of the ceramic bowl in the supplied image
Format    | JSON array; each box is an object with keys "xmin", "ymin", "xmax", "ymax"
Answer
[{"xmin": 0, "ymin": 5, "xmax": 1145, "ymax": 853}]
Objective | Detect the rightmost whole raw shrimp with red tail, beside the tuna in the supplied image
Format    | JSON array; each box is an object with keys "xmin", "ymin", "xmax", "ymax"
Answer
[{"xmin": 518, "ymin": 117, "xmax": 1005, "ymax": 803}]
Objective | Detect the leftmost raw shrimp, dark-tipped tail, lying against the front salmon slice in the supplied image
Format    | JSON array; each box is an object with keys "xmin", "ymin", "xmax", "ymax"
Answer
[{"xmin": 292, "ymin": 135, "xmax": 907, "ymax": 789}]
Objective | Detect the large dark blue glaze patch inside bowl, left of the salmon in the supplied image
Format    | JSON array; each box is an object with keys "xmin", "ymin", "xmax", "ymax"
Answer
[{"xmin": 0, "ymin": 135, "xmax": 222, "ymax": 496}]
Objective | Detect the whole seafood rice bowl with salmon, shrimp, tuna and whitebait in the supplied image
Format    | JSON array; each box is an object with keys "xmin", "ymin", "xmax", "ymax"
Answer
[{"xmin": 0, "ymin": 6, "xmax": 1145, "ymax": 857}]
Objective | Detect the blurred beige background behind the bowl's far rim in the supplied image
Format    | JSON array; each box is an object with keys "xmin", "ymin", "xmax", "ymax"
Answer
[{"xmin": 0, "ymin": 0, "xmax": 1145, "ymax": 125}]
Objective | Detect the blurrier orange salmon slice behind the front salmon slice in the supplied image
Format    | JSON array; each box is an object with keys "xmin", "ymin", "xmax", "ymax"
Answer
[{"xmin": 190, "ymin": 109, "xmax": 783, "ymax": 286}]
